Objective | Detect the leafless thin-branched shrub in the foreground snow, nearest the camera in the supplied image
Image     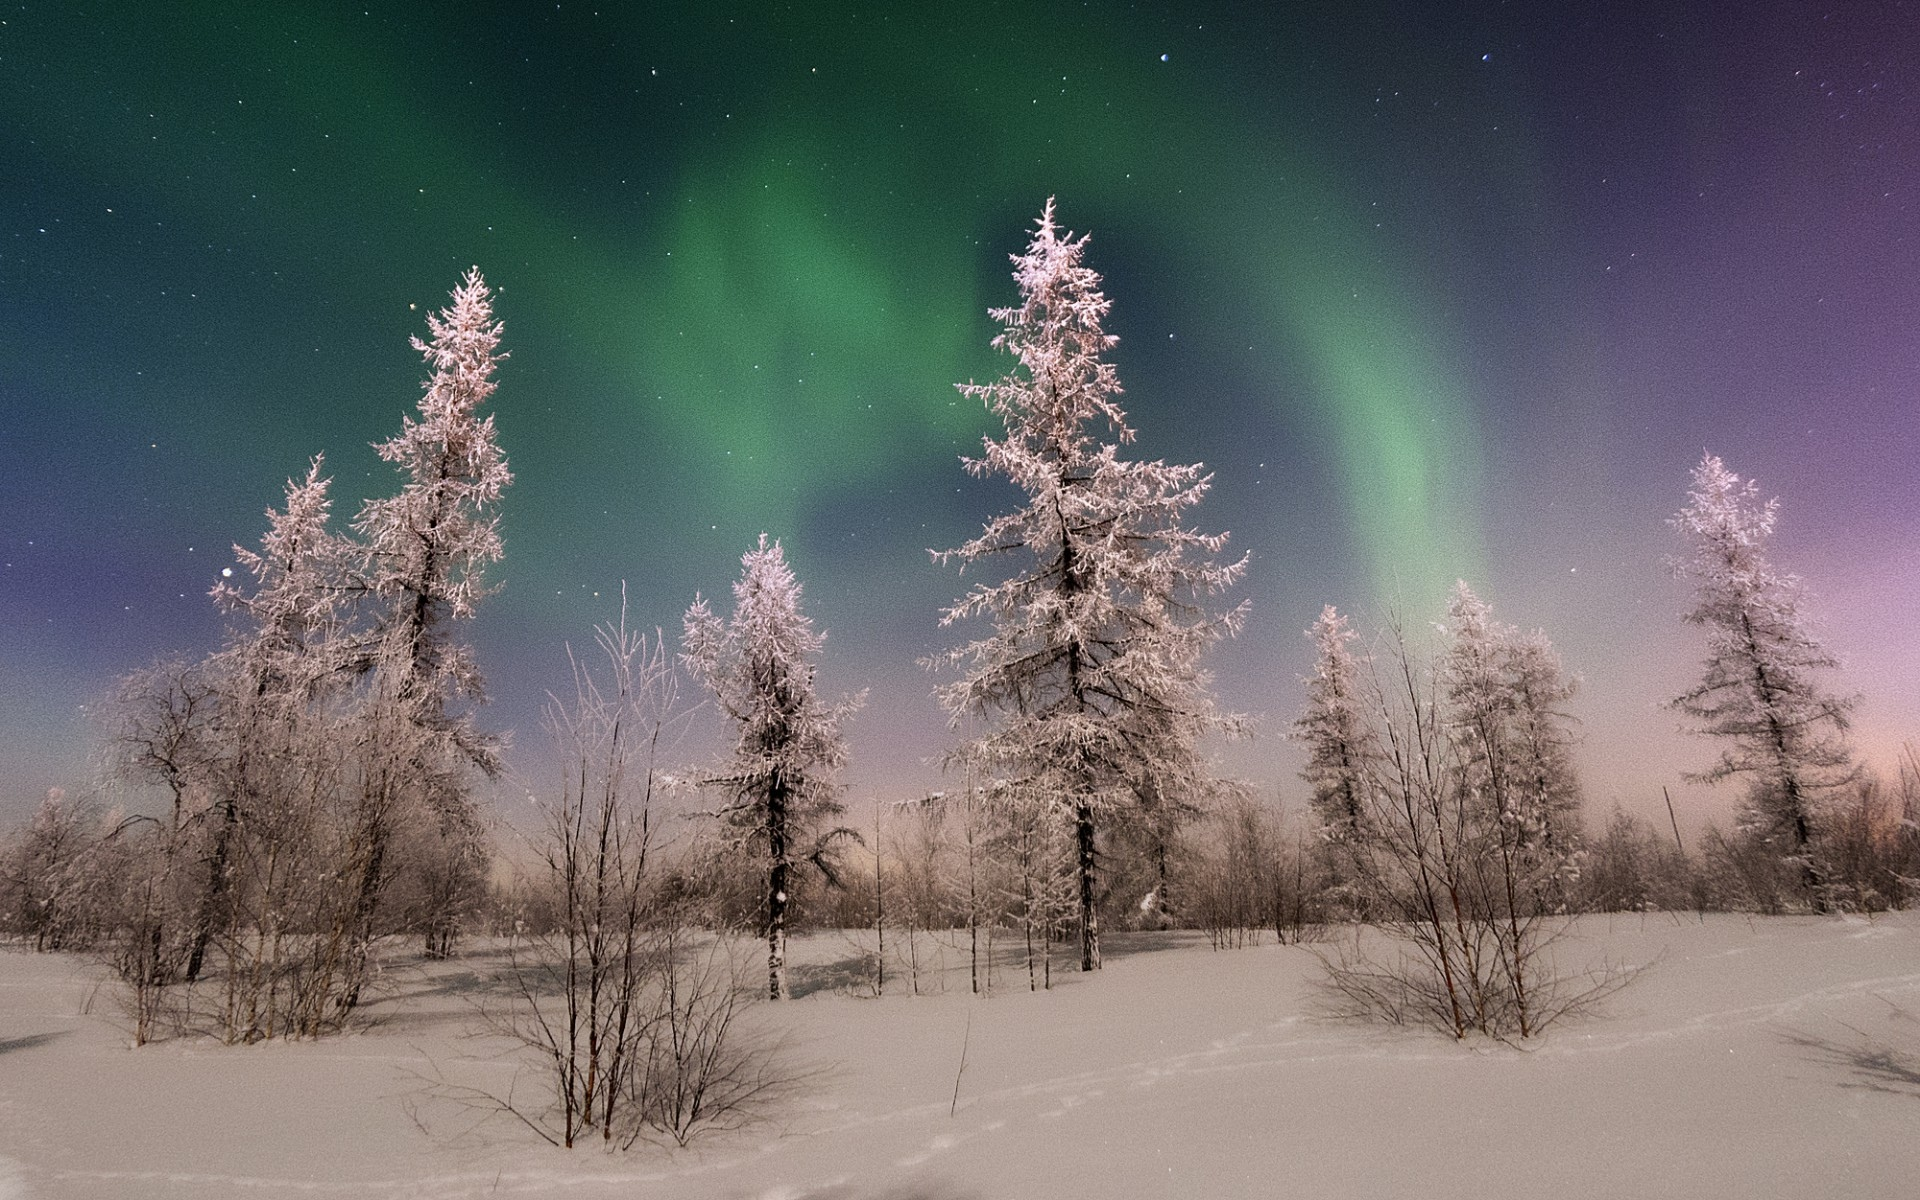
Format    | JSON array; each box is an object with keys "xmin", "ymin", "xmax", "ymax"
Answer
[{"xmin": 488, "ymin": 616, "xmax": 785, "ymax": 1148}]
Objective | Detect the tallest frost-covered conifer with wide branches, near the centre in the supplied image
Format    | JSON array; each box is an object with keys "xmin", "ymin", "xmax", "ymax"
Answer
[{"xmin": 931, "ymin": 200, "xmax": 1246, "ymax": 972}]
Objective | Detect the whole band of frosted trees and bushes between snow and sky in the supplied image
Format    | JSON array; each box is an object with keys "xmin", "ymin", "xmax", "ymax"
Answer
[{"xmin": 0, "ymin": 200, "xmax": 1920, "ymax": 1059}]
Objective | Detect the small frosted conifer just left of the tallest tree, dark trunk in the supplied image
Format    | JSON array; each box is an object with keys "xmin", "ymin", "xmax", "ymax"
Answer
[{"xmin": 680, "ymin": 534, "xmax": 858, "ymax": 1000}]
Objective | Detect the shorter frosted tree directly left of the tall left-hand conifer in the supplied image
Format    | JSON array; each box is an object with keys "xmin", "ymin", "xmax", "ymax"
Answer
[{"xmin": 188, "ymin": 457, "xmax": 372, "ymax": 1041}]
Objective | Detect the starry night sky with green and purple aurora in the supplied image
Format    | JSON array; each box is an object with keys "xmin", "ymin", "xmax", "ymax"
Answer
[{"xmin": 0, "ymin": 0, "xmax": 1920, "ymax": 824}]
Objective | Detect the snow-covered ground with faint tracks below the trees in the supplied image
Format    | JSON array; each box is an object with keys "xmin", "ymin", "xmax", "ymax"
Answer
[{"xmin": 0, "ymin": 914, "xmax": 1920, "ymax": 1200}]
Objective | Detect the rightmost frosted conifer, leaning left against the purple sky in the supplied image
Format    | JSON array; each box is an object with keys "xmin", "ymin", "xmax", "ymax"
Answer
[{"xmin": 1670, "ymin": 453, "xmax": 1859, "ymax": 908}]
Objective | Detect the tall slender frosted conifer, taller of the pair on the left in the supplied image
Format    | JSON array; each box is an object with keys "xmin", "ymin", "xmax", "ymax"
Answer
[{"xmin": 353, "ymin": 267, "xmax": 513, "ymax": 967}]
